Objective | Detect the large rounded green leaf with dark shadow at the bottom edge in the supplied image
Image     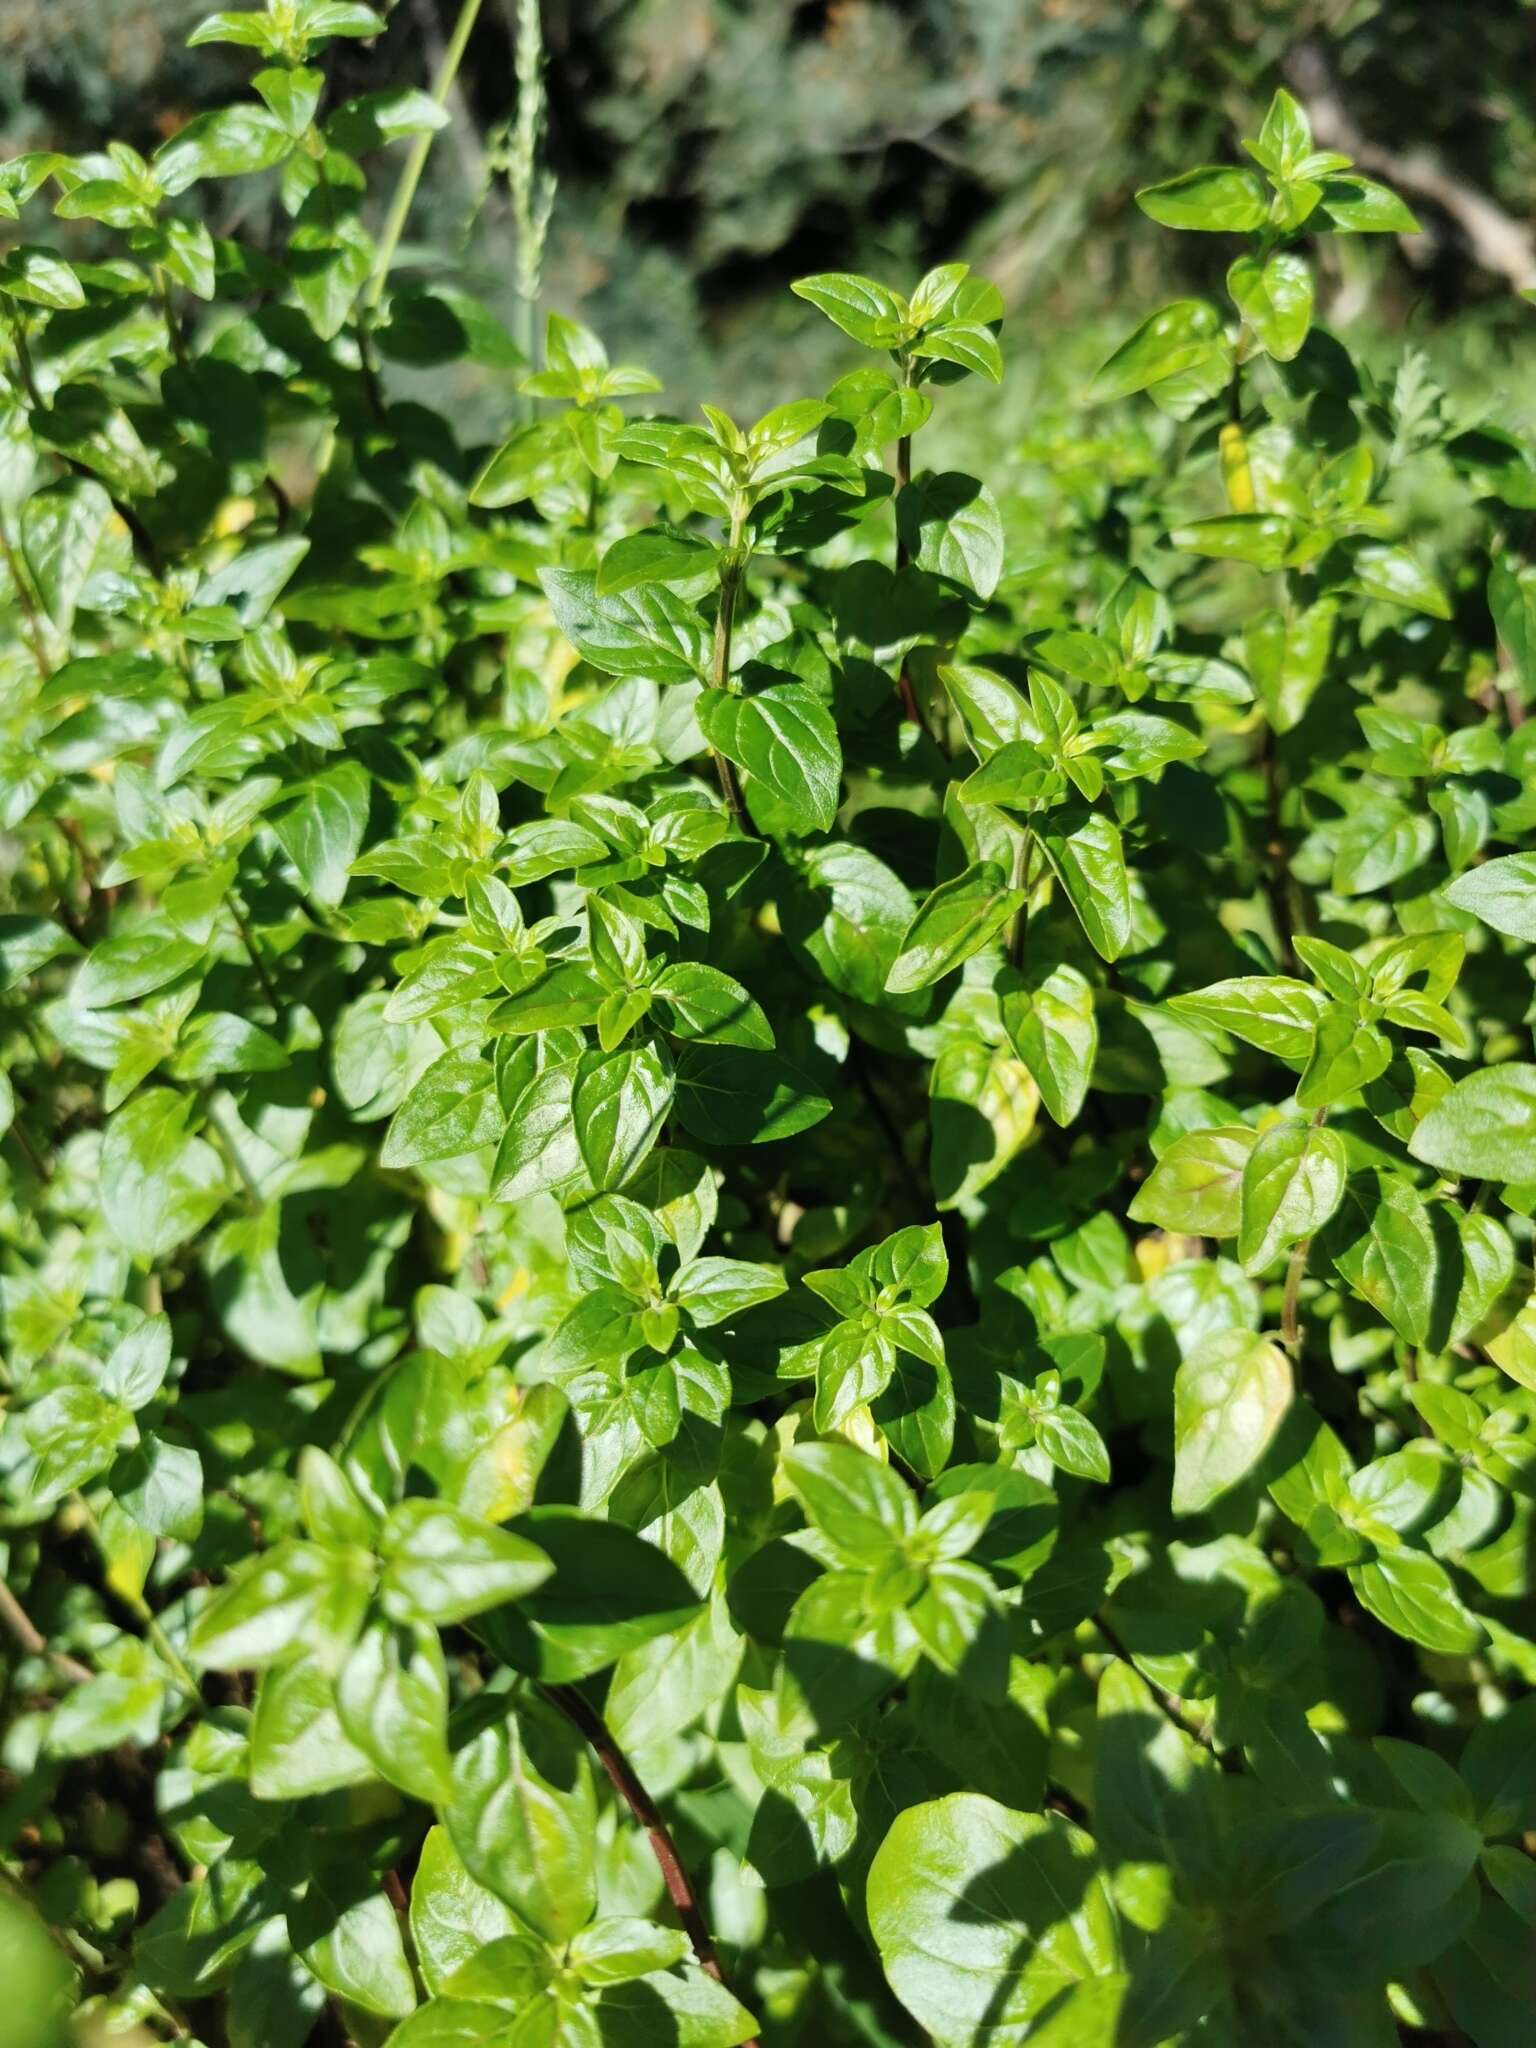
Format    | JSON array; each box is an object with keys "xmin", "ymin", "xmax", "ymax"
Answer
[{"xmin": 864, "ymin": 1792, "xmax": 1128, "ymax": 2048}]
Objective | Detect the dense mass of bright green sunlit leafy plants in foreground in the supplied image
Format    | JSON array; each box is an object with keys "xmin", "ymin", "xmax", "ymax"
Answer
[{"xmin": 0, "ymin": 0, "xmax": 1536, "ymax": 2048}]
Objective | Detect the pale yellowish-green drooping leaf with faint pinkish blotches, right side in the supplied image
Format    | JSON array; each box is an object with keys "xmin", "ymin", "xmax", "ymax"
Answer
[{"xmin": 1174, "ymin": 1329, "xmax": 1292, "ymax": 1516}]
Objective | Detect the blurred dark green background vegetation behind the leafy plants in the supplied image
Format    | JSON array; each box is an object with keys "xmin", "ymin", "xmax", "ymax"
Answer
[{"xmin": 0, "ymin": 0, "xmax": 1536, "ymax": 432}]
